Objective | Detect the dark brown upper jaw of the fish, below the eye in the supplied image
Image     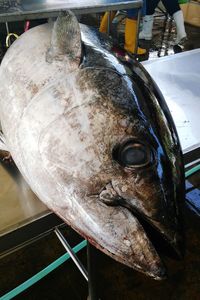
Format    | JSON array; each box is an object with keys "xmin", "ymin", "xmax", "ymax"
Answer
[{"xmin": 107, "ymin": 162, "xmax": 184, "ymax": 257}]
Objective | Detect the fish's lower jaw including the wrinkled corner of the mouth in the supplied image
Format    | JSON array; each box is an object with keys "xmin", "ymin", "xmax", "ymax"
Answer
[{"xmin": 87, "ymin": 191, "xmax": 166, "ymax": 280}]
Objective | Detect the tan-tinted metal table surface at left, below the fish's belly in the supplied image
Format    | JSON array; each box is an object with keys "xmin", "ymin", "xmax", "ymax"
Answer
[{"xmin": 0, "ymin": 163, "xmax": 49, "ymax": 236}]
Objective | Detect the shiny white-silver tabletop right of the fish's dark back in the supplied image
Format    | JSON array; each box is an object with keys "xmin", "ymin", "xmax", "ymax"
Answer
[{"xmin": 143, "ymin": 49, "xmax": 200, "ymax": 160}]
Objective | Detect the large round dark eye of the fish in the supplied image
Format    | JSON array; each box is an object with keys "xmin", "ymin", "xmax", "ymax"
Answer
[{"xmin": 113, "ymin": 140, "xmax": 153, "ymax": 168}]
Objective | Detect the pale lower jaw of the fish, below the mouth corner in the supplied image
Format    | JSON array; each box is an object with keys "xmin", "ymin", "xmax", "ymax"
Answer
[{"xmin": 54, "ymin": 196, "xmax": 166, "ymax": 280}]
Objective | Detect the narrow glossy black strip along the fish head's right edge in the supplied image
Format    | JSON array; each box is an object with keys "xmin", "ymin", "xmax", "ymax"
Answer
[{"xmin": 128, "ymin": 62, "xmax": 185, "ymax": 256}]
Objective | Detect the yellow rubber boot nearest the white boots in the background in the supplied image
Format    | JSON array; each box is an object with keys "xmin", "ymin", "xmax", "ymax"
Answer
[{"xmin": 124, "ymin": 18, "xmax": 146, "ymax": 55}]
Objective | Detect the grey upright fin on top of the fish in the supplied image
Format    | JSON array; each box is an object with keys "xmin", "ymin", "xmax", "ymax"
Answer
[{"xmin": 46, "ymin": 11, "xmax": 81, "ymax": 65}]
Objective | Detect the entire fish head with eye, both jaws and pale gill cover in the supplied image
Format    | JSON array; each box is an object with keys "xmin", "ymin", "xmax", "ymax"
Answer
[{"xmin": 40, "ymin": 11, "xmax": 184, "ymax": 279}]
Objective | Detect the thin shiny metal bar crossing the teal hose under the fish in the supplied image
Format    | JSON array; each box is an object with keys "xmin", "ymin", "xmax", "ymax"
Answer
[{"xmin": 54, "ymin": 228, "xmax": 88, "ymax": 281}]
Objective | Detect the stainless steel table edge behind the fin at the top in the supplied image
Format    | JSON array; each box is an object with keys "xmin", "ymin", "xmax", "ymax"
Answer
[{"xmin": 0, "ymin": 0, "xmax": 143, "ymax": 22}]
